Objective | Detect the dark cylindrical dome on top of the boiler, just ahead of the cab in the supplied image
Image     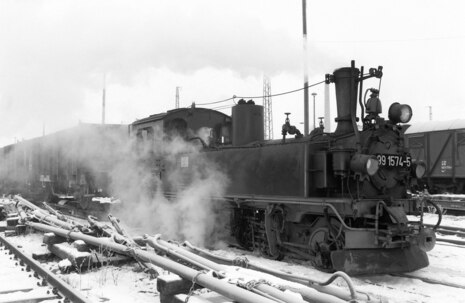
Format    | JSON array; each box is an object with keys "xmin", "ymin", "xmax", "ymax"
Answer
[{"xmin": 232, "ymin": 101, "xmax": 265, "ymax": 146}]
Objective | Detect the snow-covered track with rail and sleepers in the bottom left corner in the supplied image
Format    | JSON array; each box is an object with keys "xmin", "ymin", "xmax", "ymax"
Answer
[{"xmin": 0, "ymin": 234, "xmax": 90, "ymax": 303}]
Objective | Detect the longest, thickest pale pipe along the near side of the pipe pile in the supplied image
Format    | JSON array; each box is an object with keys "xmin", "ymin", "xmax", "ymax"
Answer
[{"xmin": 26, "ymin": 222, "xmax": 276, "ymax": 303}]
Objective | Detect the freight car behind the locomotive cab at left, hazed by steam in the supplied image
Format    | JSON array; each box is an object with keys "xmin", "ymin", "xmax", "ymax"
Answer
[{"xmin": 0, "ymin": 124, "xmax": 128, "ymax": 215}]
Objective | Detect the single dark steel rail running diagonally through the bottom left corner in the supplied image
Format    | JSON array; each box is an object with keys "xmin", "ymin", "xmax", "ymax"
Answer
[{"xmin": 0, "ymin": 235, "xmax": 91, "ymax": 303}]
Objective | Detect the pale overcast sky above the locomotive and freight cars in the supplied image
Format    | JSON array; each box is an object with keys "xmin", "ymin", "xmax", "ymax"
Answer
[{"xmin": 0, "ymin": 0, "xmax": 465, "ymax": 146}]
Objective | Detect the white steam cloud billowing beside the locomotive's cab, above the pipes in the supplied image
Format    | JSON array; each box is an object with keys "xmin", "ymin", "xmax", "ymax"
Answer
[{"xmin": 112, "ymin": 130, "xmax": 232, "ymax": 246}]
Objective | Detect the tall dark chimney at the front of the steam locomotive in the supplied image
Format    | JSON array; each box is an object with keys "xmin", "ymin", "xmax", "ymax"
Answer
[{"xmin": 333, "ymin": 67, "xmax": 360, "ymax": 134}]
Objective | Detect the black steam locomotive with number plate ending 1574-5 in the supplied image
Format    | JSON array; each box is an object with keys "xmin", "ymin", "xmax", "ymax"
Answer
[{"xmin": 132, "ymin": 63, "xmax": 435, "ymax": 274}]
